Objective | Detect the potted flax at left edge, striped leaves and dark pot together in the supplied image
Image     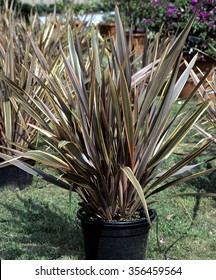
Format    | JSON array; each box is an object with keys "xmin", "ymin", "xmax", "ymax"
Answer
[{"xmin": 0, "ymin": 13, "xmax": 37, "ymax": 188}]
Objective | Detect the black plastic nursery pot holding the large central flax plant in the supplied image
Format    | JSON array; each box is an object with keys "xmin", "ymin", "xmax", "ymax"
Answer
[{"xmin": 77, "ymin": 209, "xmax": 156, "ymax": 260}]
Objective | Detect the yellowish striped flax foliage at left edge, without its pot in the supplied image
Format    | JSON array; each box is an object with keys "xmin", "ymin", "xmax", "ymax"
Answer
[{"xmin": 0, "ymin": 14, "xmax": 40, "ymax": 158}]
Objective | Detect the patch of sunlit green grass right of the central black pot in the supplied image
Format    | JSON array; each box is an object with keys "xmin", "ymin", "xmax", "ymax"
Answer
[{"xmin": 148, "ymin": 185, "xmax": 216, "ymax": 260}]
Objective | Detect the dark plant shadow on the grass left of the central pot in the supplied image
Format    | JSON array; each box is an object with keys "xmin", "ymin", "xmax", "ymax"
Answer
[{"xmin": 0, "ymin": 194, "xmax": 83, "ymax": 259}]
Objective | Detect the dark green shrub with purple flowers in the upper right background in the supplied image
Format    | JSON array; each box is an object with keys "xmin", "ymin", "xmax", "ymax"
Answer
[{"xmin": 114, "ymin": 0, "xmax": 216, "ymax": 56}]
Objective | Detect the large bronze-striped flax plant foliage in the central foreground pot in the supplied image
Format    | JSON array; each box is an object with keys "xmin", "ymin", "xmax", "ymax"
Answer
[{"xmin": 1, "ymin": 8, "xmax": 215, "ymax": 223}]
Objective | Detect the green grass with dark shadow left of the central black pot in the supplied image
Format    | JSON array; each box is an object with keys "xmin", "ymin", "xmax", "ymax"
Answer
[{"xmin": 0, "ymin": 181, "xmax": 83, "ymax": 259}]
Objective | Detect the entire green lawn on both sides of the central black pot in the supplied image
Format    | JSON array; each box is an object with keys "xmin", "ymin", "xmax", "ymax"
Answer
[{"xmin": 0, "ymin": 171, "xmax": 216, "ymax": 260}]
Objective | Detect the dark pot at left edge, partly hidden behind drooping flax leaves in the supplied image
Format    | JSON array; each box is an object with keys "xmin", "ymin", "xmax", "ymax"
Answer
[{"xmin": 0, "ymin": 160, "xmax": 35, "ymax": 189}]
